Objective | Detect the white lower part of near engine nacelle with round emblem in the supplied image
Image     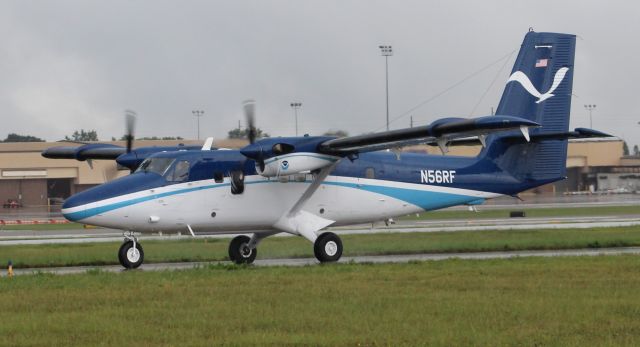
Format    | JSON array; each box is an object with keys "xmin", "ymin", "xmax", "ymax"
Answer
[{"xmin": 256, "ymin": 152, "xmax": 340, "ymax": 177}]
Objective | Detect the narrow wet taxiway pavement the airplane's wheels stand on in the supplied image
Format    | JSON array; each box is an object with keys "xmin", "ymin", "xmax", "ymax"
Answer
[{"xmin": 5, "ymin": 247, "xmax": 640, "ymax": 276}]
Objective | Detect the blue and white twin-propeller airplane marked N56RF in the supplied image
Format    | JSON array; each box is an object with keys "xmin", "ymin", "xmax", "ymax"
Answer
[{"xmin": 43, "ymin": 32, "xmax": 608, "ymax": 268}]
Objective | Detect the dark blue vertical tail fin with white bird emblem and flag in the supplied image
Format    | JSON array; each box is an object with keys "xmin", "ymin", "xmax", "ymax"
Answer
[{"xmin": 481, "ymin": 32, "xmax": 576, "ymax": 187}]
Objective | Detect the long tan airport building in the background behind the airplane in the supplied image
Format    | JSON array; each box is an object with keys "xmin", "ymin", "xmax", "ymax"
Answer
[{"xmin": 0, "ymin": 139, "xmax": 640, "ymax": 208}]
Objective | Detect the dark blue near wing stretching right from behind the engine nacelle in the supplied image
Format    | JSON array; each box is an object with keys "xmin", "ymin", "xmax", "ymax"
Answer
[{"xmin": 318, "ymin": 116, "xmax": 540, "ymax": 155}]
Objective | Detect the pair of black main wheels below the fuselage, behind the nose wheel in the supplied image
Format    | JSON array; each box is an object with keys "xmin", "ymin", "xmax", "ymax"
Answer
[{"xmin": 229, "ymin": 232, "xmax": 342, "ymax": 264}]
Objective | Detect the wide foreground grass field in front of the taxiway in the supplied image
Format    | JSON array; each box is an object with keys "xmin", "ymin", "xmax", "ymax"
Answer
[{"xmin": 0, "ymin": 256, "xmax": 640, "ymax": 346}]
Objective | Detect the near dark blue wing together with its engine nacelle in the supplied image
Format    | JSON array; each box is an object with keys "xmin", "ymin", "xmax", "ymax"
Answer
[{"xmin": 240, "ymin": 116, "xmax": 540, "ymax": 177}]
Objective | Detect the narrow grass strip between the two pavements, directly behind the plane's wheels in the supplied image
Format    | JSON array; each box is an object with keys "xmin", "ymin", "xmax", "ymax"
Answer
[{"xmin": 0, "ymin": 227, "xmax": 640, "ymax": 268}]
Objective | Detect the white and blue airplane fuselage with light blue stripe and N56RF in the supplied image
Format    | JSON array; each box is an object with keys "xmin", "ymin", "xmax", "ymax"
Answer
[{"xmin": 62, "ymin": 151, "xmax": 509, "ymax": 233}]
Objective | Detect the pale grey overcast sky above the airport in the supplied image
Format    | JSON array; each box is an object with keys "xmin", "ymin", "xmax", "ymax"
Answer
[{"xmin": 0, "ymin": 0, "xmax": 640, "ymax": 146}]
